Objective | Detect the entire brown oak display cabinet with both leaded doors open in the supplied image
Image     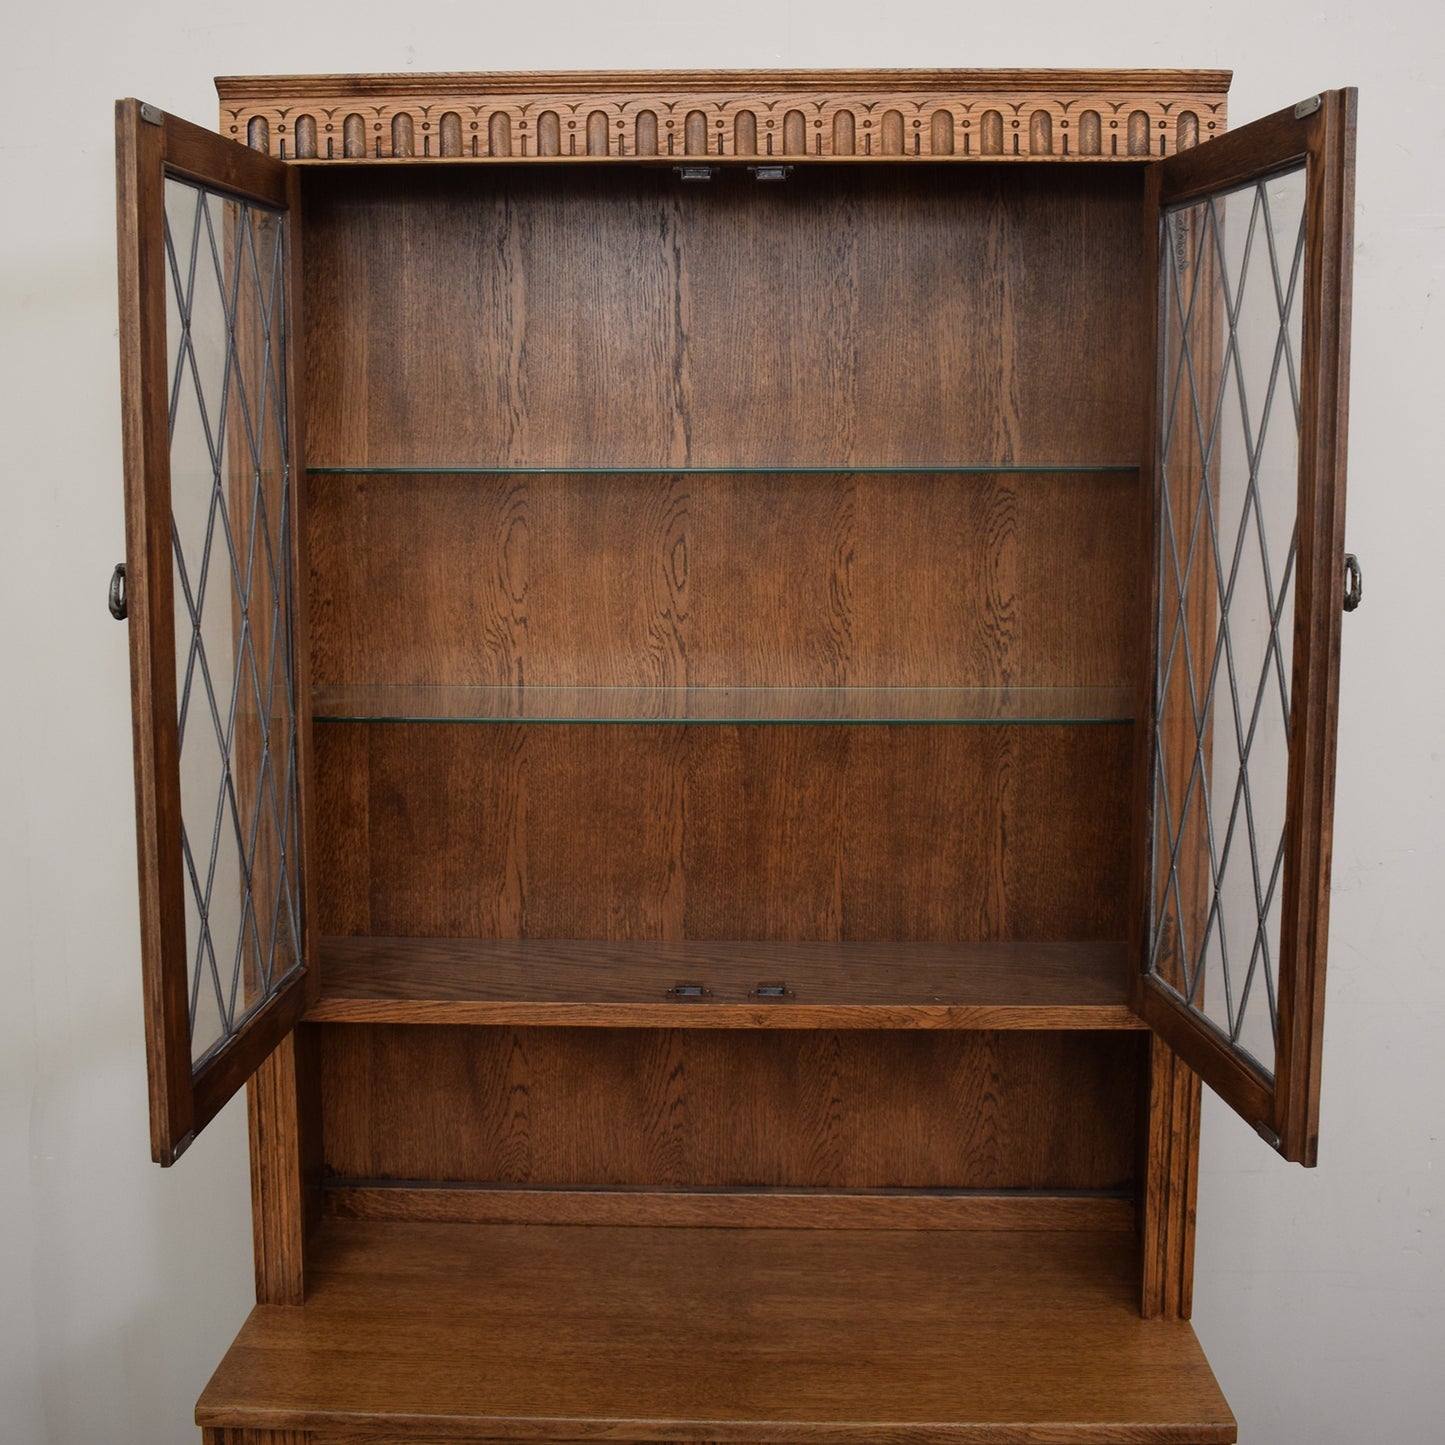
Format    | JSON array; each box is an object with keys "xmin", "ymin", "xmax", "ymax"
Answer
[{"xmin": 113, "ymin": 71, "xmax": 1358, "ymax": 1445}]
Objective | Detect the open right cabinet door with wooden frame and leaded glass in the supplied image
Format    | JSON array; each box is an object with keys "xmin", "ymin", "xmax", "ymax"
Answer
[{"xmin": 1136, "ymin": 91, "xmax": 1360, "ymax": 1165}]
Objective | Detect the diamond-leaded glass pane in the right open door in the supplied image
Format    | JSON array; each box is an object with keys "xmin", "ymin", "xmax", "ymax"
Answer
[{"xmin": 1149, "ymin": 166, "xmax": 1305, "ymax": 1075}]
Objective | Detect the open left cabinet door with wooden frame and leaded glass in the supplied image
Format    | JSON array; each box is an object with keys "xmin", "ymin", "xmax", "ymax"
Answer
[{"xmin": 111, "ymin": 100, "xmax": 314, "ymax": 1165}]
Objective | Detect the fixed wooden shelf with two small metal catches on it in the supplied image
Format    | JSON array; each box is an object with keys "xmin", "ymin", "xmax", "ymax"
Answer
[{"xmin": 306, "ymin": 938, "xmax": 1144, "ymax": 1029}]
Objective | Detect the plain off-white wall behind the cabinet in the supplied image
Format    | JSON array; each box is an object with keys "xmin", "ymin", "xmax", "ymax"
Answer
[{"xmin": 0, "ymin": 0, "xmax": 1445, "ymax": 1445}]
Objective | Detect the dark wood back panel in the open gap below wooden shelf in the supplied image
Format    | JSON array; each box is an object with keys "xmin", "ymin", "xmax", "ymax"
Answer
[{"xmin": 318, "ymin": 1025, "xmax": 1142, "ymax": 1189}]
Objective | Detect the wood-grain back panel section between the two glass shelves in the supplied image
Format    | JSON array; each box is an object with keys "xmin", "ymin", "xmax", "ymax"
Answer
[{"xmin": 309, "ymin": 473, "xmax": 1139, "ymax": 686}]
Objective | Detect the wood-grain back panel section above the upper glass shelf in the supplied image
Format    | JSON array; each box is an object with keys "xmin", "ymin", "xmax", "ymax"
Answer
[{"xmin": 305, "ymin": 166, "xmax": 1147, "ymax": 465}]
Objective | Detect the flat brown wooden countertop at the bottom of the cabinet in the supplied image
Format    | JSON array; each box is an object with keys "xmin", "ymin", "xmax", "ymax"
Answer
[{"xmin": 197, "ymin": 1221, "xmax": 1235, "ymax": 1445}]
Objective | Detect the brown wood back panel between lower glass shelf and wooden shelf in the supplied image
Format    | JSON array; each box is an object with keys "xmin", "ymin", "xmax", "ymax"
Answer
[{"xmin": 316, "ymin": 723, "xmax": 1129, "ymax": 942}]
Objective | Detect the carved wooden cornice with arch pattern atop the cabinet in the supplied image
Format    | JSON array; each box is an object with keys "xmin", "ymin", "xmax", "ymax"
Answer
[{"xmin": 215, "ymin": 69, "xmax": 1231, "ymax": 163}]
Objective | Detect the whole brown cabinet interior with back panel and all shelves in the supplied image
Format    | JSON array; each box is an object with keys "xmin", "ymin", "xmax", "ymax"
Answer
[{"xmin": 302, "ymin": 165, "xmax": 1149, "ymax": 1209}]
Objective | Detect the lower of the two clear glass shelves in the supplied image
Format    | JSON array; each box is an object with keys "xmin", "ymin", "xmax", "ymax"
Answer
[{"xmin": 311, "ymin": 683, "xmax": 1134, "ymax": 724}]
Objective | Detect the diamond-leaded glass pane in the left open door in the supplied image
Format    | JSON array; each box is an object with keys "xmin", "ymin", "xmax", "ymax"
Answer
[{"xmin": 166, "ymin": 178, "xmax": 301, "ymax": 1066}]
